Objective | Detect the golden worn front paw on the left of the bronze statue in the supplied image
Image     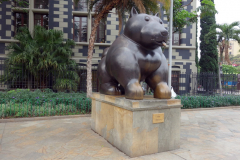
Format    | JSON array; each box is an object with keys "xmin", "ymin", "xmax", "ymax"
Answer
[{"xmin": 125, "ymin": 82, "xmax": 143, "ymax": 99}]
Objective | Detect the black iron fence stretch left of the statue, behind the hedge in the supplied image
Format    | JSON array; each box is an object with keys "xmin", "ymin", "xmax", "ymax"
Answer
[{"xmin": 0, "ymin": 60, "xmax": 98, "ymax": 92}]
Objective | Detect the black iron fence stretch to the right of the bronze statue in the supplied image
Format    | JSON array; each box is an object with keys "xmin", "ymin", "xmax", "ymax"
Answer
[{"xmin": 172, "ymin": 72, "xmax": 240, "ymax": 95}]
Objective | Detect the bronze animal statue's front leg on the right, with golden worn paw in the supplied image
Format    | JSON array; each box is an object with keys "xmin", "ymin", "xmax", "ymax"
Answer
[{"xmin": 146, "ymin": 61, "xmax": 171, "ymax": 99}]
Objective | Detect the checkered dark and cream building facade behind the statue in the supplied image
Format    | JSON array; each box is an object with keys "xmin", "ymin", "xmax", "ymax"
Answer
[{"xmin": 0, "ymin": 0, "xmax": 197, "ymax": 94}]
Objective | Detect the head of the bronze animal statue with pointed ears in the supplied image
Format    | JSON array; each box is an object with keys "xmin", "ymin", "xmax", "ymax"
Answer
[{"xmin": 124, "ymin": 8, "xmax": 168, "ymax": 49}]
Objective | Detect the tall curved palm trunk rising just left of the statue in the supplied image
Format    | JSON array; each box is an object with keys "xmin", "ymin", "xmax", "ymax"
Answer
[{"xmin": 87, "ymin": 0, "xmax": 121, "ymax": 98}]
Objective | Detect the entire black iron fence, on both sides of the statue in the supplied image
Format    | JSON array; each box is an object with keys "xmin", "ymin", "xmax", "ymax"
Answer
[{"xmin": 0, "ymin": 60, "xmax": 240, "ymax": 95}]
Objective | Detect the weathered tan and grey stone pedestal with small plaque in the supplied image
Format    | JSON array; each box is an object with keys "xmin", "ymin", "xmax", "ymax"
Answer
[{"xmin": 91, "ymin": 93, "xmax": 182, "ymax": 157}]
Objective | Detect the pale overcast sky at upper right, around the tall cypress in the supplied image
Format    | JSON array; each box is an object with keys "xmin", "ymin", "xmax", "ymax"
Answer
[{"xmin": 197, "ymin": 0, "xmax": 240, "ymax": 58}]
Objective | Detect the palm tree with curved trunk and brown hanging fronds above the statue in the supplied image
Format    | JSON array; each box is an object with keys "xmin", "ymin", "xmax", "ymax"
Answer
[{"xmin": 83, "ymin": 0, "xmax": 163, "ymax": 97}]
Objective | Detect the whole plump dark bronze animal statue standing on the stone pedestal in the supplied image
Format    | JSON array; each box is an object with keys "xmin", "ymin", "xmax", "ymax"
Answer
[{"xmin": 98, "ymin": 8, "xmax": 171, "ymax": 99}]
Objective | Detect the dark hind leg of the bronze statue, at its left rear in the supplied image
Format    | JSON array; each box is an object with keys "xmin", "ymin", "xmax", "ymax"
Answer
[{"xmin": 98, "ymin": 57, "xmax": 124, "ymax": 95}]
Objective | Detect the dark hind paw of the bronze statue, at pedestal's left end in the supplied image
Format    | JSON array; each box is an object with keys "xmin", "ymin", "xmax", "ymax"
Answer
[{"xmin": 100, "ymin": 83, "xmax": 122, "ymax": 95}]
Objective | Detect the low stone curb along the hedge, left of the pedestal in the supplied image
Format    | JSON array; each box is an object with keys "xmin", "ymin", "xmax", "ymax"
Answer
[{"xmin": 0, "ymin": 114, "xmax": 91, "ymax": 123}]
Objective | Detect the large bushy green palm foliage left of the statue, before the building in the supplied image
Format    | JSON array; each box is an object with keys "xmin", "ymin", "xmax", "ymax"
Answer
[{"xmin": 0, "ymin": 26, "xmax": 79, "ymax": 91}]
